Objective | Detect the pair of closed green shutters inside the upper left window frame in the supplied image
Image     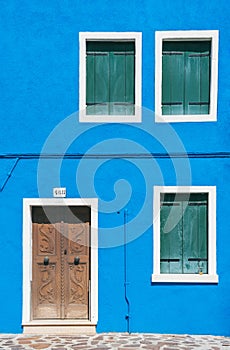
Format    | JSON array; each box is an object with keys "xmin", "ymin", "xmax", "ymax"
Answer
[{"xmin": 86, "ymin": 41, "xmax": 135, "ymax": 115}]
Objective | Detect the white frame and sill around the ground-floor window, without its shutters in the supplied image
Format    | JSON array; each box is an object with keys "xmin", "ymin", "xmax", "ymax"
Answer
[{"xmin": 152, "ymin": 186, "xmax": 218, "ymax": 283}]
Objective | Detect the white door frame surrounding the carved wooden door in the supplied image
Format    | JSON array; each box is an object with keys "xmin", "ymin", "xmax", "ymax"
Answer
[{"xmin": 22, "ymin": 198, "xmax": 98, "ymax": 326}]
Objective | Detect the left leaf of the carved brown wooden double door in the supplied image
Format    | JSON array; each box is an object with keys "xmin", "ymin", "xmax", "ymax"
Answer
[{"xmin": 32, "ymin": 223, "xmax": 61, "ymax": 319}]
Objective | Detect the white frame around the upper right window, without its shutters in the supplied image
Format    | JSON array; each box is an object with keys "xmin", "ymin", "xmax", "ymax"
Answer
[{"xmin": 155, "ymin": 30, "xmax": 219, "ymax": 123}]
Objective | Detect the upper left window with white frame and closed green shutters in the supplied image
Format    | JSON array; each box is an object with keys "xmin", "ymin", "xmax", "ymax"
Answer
[{"xmin": 80, "ymin": 33, "xmax": 141, "ymax": 123}]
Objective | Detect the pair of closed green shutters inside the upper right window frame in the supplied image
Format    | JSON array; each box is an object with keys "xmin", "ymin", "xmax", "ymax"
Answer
[{"xmin": 162, "ymin": 41, "xmax": 211, "ymax": 115}]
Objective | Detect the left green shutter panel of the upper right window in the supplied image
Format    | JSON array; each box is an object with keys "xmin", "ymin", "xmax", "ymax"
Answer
[{"xmin": 162, "ymin": 42, "xmax": 185, "ymax": 115}]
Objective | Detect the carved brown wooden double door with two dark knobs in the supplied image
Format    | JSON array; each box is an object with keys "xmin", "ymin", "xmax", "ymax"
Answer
[{"xmin": 32, "ymin": 222, "xmax": 89, "ymax": 319}]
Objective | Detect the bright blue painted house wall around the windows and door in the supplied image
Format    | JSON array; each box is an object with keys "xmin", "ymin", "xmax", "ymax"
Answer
[{"xmin": 0, "ymin": 0, "xmax": 230, "ymax": 335}]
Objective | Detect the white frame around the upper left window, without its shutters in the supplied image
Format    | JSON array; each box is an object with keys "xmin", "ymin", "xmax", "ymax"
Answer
[{"xmin": 79, "ymin": 32, "xmax": 142, "ymax": 123}]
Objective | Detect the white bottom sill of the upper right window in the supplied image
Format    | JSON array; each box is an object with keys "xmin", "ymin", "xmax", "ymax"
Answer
[{"xmin": 155, "ymin": 113, "xmax": 217, "ymax": 123}]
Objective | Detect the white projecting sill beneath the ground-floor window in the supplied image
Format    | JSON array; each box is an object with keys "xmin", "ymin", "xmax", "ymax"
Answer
[{"xmin": 152, "ymin": 274, "xmax": 219, "ymax": 283}]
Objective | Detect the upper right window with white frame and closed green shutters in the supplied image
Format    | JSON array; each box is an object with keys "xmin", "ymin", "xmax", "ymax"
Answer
[{"xmin": 155, "ymin": 31, "xmax": 218, "ymax": 122}]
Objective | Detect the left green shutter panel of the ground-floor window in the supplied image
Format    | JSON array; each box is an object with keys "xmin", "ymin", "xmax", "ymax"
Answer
[{"xmin": 160, "ymin": 197, "xmax": 183, "ymax": 274}]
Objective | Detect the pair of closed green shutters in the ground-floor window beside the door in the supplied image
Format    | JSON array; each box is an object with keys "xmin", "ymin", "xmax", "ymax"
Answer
[{"xmin": 160, "ymin": 194, "xmax": 208, "ymax": 274}]
